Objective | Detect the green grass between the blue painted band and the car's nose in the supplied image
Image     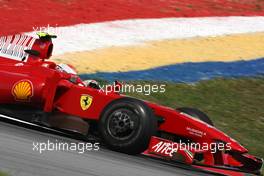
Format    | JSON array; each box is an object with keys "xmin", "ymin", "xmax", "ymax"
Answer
[{"xmin": 125, "ymin": 77, "xmax": 264, "ymax": 158}]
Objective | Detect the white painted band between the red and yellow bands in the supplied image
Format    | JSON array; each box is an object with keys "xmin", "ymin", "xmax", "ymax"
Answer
[{"xmin": 25, "ymin": 17, "xmax": 264, "ymax": 55}]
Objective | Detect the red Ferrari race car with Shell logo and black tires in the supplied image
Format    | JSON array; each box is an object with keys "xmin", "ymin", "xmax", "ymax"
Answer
[{"xmin": 0, "ymin": 33, "xmax": 263, "ymax": 175}]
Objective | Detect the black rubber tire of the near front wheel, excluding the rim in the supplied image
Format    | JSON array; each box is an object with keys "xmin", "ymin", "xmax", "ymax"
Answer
[{"xmin": 99, "ymin": 98, "xmax": 157, "ymax": 154}]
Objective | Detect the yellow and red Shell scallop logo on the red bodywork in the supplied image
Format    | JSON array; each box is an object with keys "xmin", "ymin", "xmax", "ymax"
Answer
[{"xmin": 12, "ymin": 80, "xmax": 33, "ymax": 102}]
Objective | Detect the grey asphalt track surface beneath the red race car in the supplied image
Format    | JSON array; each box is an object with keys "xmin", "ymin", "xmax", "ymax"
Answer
[{"xmin": 0, "ymin": 121, "xmax": 216, "ymax": 176}]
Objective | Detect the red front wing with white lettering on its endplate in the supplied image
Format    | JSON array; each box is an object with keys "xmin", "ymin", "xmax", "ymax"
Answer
[{"xmin": 143, "ymin": 136, "xmax": 263, "ymax": 176}]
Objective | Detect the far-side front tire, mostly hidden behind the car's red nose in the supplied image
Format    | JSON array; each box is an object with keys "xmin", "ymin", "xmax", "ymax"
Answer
[{"xmin": 176, "ymin": 107, "xmax": 214, "ymax": 126}]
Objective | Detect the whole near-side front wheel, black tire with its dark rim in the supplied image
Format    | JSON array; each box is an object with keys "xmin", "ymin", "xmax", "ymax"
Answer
[{"xmin": 99, "ymin": 98, "xmax": 157, "ymax": 154}]
